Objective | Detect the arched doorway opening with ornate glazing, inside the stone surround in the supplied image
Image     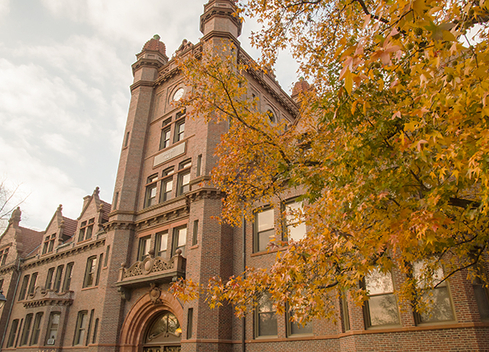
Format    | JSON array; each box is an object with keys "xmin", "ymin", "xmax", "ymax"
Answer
[{"xmin": 143, "ymin": 311, "xmax": 182, "ymax": 352}]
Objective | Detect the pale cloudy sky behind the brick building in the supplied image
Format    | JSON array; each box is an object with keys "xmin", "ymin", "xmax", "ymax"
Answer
[{"xmin": 0, "ymin": 0, "xmax": 297, "ymax": 230}]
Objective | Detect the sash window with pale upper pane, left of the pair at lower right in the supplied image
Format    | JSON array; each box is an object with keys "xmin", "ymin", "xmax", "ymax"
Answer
[{"xmin": 364, "ymin": 269, "xmax": 399, "ymax": 327}]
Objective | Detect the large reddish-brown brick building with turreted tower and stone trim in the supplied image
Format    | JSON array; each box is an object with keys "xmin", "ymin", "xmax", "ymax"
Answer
[{"xmin": 0, "ymin": 0, "xmax": 489, "ymax": 352}]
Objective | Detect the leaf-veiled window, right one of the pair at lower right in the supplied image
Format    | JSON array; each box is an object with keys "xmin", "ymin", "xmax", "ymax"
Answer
[{"xmin": 413, "ymin": 262, "xmax": 455, "ymax": 323}]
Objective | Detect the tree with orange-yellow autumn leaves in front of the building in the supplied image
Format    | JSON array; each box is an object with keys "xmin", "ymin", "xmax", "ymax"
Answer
[{"xmin": 175, "ymin": 0, "xmax": 489, "ymax": 320}]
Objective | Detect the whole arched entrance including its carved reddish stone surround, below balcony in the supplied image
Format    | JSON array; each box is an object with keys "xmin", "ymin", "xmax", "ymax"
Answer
[{"xmin": 119, "ymin": 290, "xmax": 183, "ymax": 352}]
